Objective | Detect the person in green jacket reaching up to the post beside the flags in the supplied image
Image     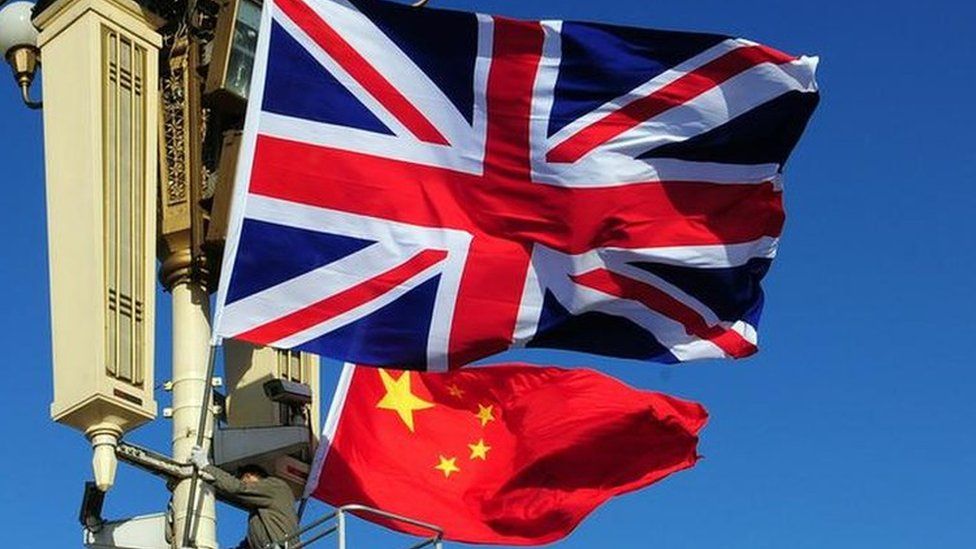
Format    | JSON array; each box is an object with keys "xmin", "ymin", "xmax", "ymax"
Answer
[{"xmin": 190, "ymin": 447, "xmax": 298, "ymax": 549}]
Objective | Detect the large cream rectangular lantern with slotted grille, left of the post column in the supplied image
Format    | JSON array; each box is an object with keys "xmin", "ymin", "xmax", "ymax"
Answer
[{"xmin": 35, "ymin": 0, "xmax": 161, "ymax": 490}]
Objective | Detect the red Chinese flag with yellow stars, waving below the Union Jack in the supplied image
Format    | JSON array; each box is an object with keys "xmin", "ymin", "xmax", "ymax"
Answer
[{"xmin": 309, "ymin": 364, "xmax": 708, "ymax": 545}]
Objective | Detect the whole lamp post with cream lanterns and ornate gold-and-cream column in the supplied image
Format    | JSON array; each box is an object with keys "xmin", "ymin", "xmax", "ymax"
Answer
[{"xmin": 0, "ymin": 0, "xmax": 318, "ymax": 548}]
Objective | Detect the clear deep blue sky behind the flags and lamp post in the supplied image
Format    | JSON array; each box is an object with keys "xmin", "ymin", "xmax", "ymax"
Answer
[{"xmin": 0, "ymin": 0, "xmax": 976, "ymax": 548}]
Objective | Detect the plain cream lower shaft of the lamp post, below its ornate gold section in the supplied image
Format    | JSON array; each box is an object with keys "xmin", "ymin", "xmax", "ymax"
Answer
[{"xmin": 172, "ymin": 278, "xmax": 217, "ymax": 549}]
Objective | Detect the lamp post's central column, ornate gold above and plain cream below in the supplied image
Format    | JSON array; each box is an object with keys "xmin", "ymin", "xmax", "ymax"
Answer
[{"xmin": 158, "ymin": 32, "xmax": 217, "ymax": 548}]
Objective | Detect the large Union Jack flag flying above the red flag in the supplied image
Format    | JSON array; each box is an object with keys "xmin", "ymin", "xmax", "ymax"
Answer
[{"xmin": 215, "ymin": 0, "xmax": 818, "ymax": 370}]
